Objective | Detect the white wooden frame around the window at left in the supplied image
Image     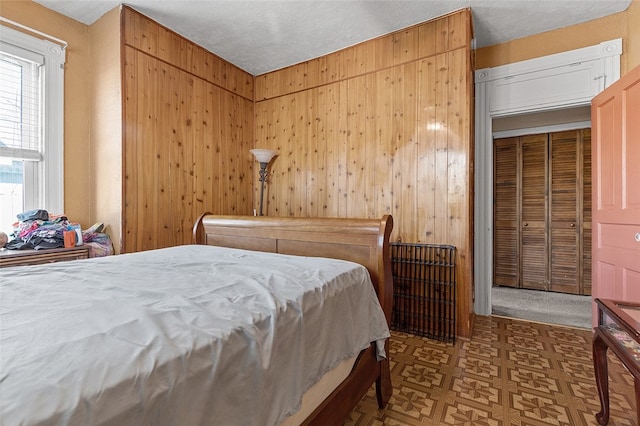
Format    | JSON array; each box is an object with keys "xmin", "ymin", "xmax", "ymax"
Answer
[{"xmin": 0, "ymin": 25, "xmax": 66, "ymax": 214}]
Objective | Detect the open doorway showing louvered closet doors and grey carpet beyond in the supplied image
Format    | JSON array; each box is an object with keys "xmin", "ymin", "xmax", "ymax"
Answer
[{"xmin": 490, "ymin": 111, "xmax": 591, "ymax": 328}]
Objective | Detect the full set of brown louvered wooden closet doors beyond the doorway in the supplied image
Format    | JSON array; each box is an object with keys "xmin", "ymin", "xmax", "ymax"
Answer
[{"xmin": 494, "ymin": 129, "xmax": 591, "ymax": 294}]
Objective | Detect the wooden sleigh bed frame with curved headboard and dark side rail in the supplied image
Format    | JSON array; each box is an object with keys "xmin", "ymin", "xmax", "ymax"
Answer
[{"xmin": 193, "ymin": 213, "xmax": 393, "ymax": 425}]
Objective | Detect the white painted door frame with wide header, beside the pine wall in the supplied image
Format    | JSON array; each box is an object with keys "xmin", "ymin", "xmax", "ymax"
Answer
[{"xmin": 473, "ymin": 38, "xmax": 622, "ymax": 316}]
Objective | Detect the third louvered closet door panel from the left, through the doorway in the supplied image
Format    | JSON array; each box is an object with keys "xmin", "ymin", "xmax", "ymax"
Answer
[{"xmin": 549, "ymin": 130, "xmax": 582, "ymax": 294}]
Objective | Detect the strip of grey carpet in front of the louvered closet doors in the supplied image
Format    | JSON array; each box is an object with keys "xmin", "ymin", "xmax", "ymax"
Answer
[{"xmin": 491, "ymin": 287, "xmax": 592, "ymax": 329}]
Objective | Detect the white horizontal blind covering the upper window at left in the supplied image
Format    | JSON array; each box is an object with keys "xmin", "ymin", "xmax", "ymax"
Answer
[{"xmin": 0, "ymin": 43, "xmax": 44, "ymax": 160}]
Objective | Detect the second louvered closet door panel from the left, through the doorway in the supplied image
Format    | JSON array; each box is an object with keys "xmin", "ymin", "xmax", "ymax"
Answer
[{"xmin": 520, "ymin": 134, "xmax": 549, "ymax": 290}]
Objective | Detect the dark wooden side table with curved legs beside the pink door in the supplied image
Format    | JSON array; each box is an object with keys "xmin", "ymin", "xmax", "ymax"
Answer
[{"xmin": 593, "ymin": 299, "xmax": 640, "ymax": 425}]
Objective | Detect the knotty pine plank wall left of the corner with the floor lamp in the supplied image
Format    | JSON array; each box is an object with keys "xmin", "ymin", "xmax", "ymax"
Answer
[{"xmin": 121, "ymin": 7, "xmax": 254, "ymax": 252}]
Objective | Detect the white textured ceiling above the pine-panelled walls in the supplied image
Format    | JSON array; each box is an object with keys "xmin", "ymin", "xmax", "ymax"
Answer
[{"xmin": 34, "ymin": 0, "xmax": 631, "ymax": 75}]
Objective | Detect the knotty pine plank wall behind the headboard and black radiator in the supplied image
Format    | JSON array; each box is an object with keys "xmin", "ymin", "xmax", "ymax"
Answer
[{"xmin": 254, "ymin": 10, "xmax": 473, "ymax": 336}]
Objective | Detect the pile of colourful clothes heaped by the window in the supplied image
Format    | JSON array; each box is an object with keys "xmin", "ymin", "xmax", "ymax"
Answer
[{"xmin": 6, "ymin": 209, "xmax": 114, "ymax": 257}]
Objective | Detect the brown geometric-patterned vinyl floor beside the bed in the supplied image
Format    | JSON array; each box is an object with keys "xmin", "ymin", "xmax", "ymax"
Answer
[{"xmin": 345, "ymin": 316, "xmax": 637, "ymax": 426}]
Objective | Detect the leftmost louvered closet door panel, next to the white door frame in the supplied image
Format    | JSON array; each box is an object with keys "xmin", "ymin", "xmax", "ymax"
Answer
[{"xmin": 493, "ymin": 138, "xmax": 520, "ymax": 287}]
